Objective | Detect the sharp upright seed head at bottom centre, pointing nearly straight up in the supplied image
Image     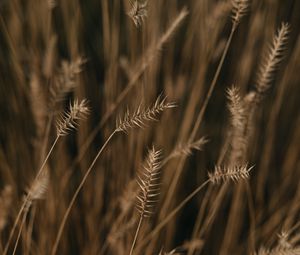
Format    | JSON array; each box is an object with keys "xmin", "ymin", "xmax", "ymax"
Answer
[{"xmin": 136, "ymin": 147, "xmax": 161, "ymax": 217}]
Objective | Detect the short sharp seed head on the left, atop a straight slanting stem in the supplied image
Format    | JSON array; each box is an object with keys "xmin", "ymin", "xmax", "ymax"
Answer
[{"xmin": 56, "ymin": 99, "xmax": 89, "ymax": 136}]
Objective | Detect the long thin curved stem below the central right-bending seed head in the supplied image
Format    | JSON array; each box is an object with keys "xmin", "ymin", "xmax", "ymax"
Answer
[{"xmin": 51, "ymin": 130, "xmax": 117, "ymax": 255}]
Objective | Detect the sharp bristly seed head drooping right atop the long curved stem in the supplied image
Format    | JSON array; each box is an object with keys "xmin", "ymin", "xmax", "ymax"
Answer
[{"xmin": 116, "ymin": 96, "xmax": 176, "ymax": 133}]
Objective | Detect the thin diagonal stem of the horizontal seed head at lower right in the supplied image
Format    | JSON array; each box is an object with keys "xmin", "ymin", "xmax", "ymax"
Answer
[{"xmin": 138, "ymin": 179, "xmax": 210, "ymax": 250}]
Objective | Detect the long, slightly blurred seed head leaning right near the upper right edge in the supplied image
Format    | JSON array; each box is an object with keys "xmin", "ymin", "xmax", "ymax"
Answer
[{"xmin": 256, "ymin": 23, "xmax": 289, "ymax": 98}]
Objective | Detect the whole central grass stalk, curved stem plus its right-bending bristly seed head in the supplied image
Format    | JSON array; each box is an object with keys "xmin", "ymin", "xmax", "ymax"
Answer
[{"xmin": 51, "ymin": 96, "xmax": 175, "ymax": 255}]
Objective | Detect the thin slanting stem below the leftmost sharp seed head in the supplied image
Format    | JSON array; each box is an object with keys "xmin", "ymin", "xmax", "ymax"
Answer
[{"xmin": 3, "ymin": 136, "xmax": 60, "ymax": 255}]
